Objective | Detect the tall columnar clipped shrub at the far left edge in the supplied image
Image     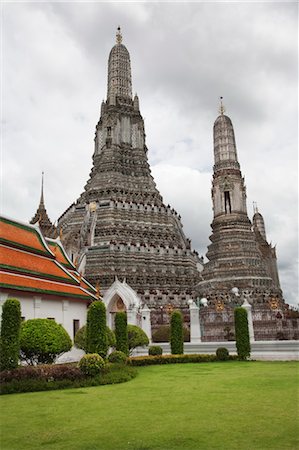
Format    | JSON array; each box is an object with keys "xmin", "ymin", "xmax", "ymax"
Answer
[{"xmin": 0, "ymin": 298, "xmax": 21, "ymax": 370}]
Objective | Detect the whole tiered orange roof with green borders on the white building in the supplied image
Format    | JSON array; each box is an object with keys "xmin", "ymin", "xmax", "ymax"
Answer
[{"xmin": 0, "ymin": 217, "xmax": 96, "ymax": 302}]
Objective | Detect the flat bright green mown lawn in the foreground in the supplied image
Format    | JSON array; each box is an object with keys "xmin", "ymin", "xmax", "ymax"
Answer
[{"xmin": 0, "ymin": 361, "xmax": 299, "ymax": 450}]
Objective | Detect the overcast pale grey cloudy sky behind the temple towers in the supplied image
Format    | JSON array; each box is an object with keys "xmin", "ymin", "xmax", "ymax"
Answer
[{"xmin": 1, "ymin": 2, "xmax": 298, "ymax": 304}]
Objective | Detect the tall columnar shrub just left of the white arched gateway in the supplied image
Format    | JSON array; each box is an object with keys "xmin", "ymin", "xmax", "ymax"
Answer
[{"xmin": 86, "ymin": 300, "xmax": 108, "ymax": 358}]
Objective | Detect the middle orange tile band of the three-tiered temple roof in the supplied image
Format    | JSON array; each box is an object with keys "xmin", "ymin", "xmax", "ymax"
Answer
[{"xmin": 0, "ymin": 245, "xmax": 79, "ymax": 284}]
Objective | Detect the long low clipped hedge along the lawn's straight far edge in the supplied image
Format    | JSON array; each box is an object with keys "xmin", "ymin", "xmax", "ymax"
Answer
[{"xmin": 130, "ymin": 354, "xmax": 238, "ymax": 366}]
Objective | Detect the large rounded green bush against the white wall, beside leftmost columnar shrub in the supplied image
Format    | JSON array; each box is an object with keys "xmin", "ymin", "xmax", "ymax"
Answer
[{"xmin": 20, "ymin": 319, "xmax": 72, "ymax": 365}]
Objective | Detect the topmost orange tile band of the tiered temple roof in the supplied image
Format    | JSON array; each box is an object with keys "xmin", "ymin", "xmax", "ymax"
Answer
[{"xmin": 0, "ymin": 217, "xmax": 53, "ymax": 258}]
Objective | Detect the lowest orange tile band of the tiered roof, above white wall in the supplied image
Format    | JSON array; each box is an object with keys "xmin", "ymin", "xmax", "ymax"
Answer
[{"xmin": 0, "ymin": 272, "xmax": 95, "ymax": 301}]
